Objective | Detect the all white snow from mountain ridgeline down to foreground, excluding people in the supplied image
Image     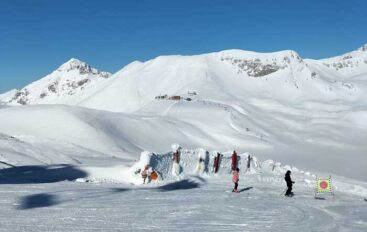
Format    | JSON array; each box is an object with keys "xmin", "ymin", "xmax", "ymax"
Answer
[{"xmin": 0, "ymin": 46, "xmax": 367, "ymax": 231}]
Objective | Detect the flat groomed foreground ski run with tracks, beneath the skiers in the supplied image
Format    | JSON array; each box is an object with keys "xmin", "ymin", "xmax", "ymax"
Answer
[{"xmin": 0, "ymin": 177, "xmax": 367, "ymax": 231}]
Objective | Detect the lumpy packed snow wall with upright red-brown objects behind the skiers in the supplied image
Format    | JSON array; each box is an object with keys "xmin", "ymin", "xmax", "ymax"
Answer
[{"xmin": 131, "ymin": 145, "xmax": 292, "ymax": 180}]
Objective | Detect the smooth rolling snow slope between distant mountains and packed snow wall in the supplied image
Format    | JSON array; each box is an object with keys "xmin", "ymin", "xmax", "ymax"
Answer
[{"xmin": 0, "ymin": 97, "xmax": 367, "ymax": 181}]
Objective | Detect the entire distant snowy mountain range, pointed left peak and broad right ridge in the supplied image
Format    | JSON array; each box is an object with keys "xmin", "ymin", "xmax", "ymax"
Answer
[{"xmin": 0, "ymin": 45, "xmax": 367, "ymax": 112}]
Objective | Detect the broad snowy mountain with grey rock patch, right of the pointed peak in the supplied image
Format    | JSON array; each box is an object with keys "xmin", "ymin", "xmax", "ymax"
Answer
[{"xmin": 62, "ymin": 46, "xmax": 367, "ymax": 112}]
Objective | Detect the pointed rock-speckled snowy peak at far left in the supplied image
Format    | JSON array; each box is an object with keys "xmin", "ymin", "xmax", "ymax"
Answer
[{"xmin": 6, "ymin": 58, "xmax": 111, "ymax": 105}]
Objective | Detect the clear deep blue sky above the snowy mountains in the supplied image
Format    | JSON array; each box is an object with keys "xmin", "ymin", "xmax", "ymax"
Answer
[{"xmin": 0, "ymin": 0, "xmax": 367, "ymax": 92}]
